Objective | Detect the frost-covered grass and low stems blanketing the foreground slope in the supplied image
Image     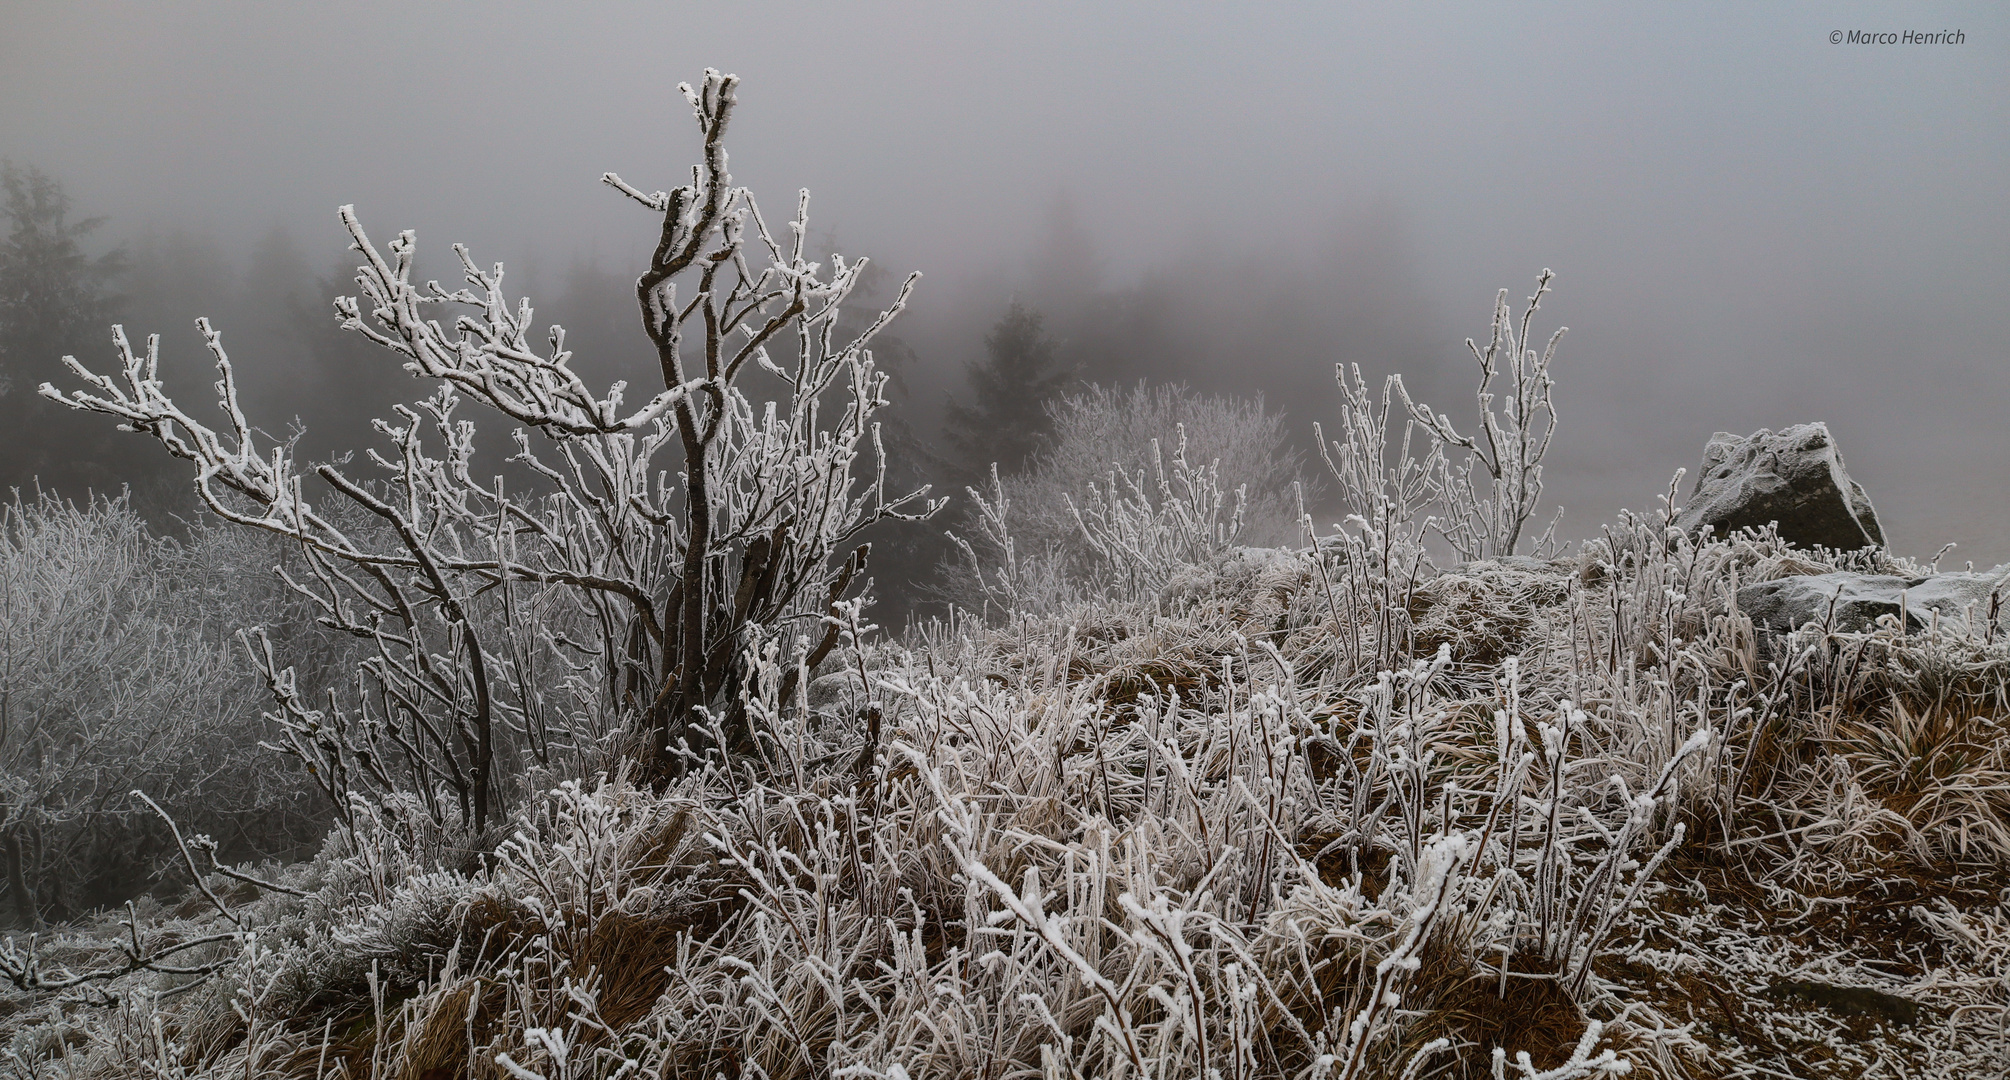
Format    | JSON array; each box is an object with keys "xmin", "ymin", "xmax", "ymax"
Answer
[{"xmin": 6, "ymin": 506, "xmax": 2010, "ymax": 1078}]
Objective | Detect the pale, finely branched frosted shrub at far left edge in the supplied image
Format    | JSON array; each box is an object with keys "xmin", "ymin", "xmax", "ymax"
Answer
[{"xmin": 0, "ymin": 495, "xmax": 326, "ymax": 925}]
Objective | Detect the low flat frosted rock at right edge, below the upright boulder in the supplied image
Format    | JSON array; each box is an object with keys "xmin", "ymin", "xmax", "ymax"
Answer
[{"xmin": 1739, "ymin": 567, "xmax": 2010, "ymax": 634}]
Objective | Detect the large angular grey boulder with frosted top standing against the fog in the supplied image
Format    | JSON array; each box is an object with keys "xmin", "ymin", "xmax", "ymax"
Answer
[{"xmin": 1674, "ymin": 424, "xmax": 1885, "ymax": 551}]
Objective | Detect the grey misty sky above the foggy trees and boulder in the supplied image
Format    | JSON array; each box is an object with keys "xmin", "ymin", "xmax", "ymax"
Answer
[{"xmin": 0, "ymin": 2, "xmax": 2010, "ymax": 565}]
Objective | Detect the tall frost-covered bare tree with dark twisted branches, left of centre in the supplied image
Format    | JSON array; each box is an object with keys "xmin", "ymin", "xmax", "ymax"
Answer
[{"xmin": 42, "ymin": 70, "xmax": 933, "ymax": 833}]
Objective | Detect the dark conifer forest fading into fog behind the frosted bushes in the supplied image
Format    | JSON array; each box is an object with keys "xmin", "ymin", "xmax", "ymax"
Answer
[{"xmin": 0, "ymin": 163, "xmax": 1445, "ymax": 611}]
